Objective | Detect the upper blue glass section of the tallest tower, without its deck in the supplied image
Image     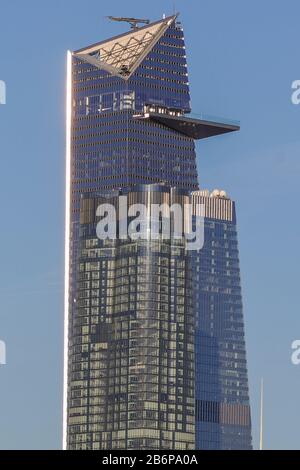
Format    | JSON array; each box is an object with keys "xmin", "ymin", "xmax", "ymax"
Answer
[{"xmin": 73, "ymin": 17, "xmax": 198, "ymax": 200}]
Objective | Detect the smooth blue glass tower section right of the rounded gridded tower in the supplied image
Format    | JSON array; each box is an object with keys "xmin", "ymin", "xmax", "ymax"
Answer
[{"xmin": 191, "ymin": 190, "xmax": 252, "ymax": 450}]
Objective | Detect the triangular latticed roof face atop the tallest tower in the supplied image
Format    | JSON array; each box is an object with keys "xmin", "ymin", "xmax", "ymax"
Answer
[{"xmin": 74, "ymin": 15, "xmax": 178, "ymax": 80}]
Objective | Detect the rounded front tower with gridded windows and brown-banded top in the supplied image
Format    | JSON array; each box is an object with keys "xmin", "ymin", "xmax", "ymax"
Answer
[{"xmin": 68, "ymin": 185, "xmax": 195, "ymax": 450}]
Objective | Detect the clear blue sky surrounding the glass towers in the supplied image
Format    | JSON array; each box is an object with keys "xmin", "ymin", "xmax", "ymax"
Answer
[{"xmin": 0, "ymin": 0, "xmax": 300, "ymax": 449}]
